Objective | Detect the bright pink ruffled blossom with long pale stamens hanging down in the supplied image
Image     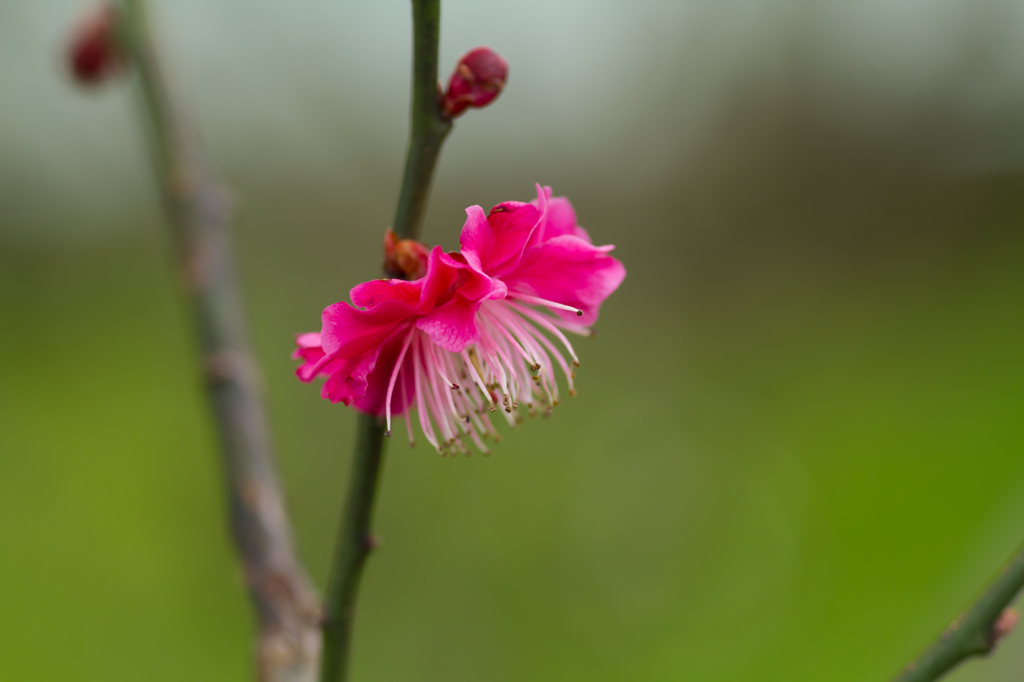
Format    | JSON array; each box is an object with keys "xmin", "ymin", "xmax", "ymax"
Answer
[{"xmin": 294, "ymin": 185, "xmax": 626, "ymax": 453}]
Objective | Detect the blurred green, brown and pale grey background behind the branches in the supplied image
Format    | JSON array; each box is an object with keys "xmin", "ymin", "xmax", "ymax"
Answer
[{"xmin": 0, "ymin": 0, "xmax": 1024, "ymax": 682}]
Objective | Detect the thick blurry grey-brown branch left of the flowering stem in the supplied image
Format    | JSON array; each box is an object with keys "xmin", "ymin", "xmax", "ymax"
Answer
[{"xmin": 121, "ymin": 0, "xmax": 321, "ymax": 682}]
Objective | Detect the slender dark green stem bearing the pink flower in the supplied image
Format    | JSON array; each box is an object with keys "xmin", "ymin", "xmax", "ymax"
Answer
[{"xmin": 321, "ymin": 0, "xmax": 452, "ymax": 682}]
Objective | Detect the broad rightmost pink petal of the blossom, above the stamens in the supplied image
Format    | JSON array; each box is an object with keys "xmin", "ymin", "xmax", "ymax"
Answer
[{"xmin": 505, "ymin": 236, "xmax": 626, "ymax": 326}]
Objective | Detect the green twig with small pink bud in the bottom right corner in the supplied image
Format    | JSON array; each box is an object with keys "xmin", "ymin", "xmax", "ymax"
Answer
[{"xmin": 895, "ymin": 547, "xmax": 1024, "ymax": 682}]
